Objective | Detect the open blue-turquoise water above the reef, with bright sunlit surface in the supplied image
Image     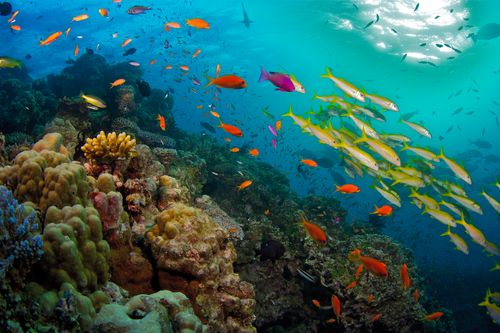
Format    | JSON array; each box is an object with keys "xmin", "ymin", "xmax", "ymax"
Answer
[{"xmin": 0, "ymin": 0, "xmax": 500, "ymax": 332}]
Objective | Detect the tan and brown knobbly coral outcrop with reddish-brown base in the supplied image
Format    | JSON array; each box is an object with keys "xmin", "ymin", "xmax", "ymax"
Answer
[{"xmin": 146, "ymin": 203, "xmax": 255, "ymax": 333}]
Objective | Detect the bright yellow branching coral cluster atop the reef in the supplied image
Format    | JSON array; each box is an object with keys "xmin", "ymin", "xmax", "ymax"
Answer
[{"xmin": 82, "ymin": 131, "xmax": 135, "ymax": 163}]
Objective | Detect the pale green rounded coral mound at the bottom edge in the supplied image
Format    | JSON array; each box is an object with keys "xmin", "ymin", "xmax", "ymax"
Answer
[{"xmin": 92, "ymin": 290, "xmax": 208, "ymax": 333}]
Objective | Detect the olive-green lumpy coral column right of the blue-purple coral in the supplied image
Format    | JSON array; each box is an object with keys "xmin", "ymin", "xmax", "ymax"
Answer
[{"xmin": 41, "ymin": 205, "xmax": 110, "ymax": 293}]
